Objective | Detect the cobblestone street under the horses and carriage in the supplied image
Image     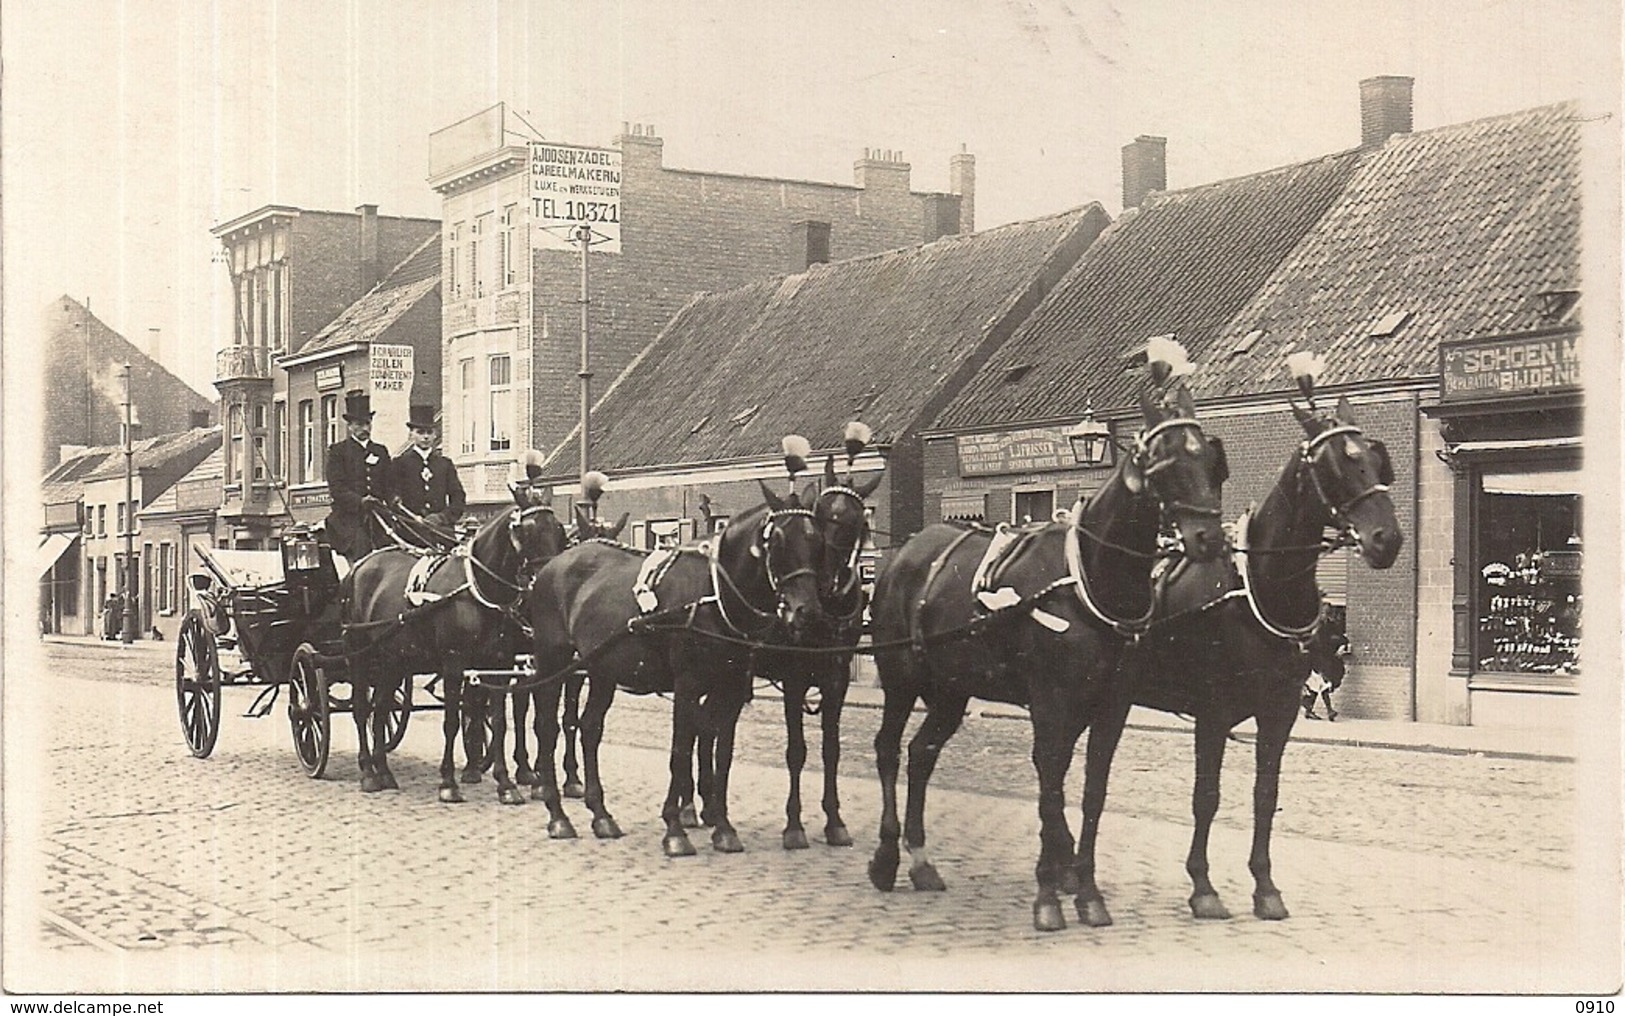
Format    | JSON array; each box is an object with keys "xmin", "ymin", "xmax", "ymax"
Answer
[{"xmin": 7, "ymin": 645, "xmax": 1617, "ymax": 992}]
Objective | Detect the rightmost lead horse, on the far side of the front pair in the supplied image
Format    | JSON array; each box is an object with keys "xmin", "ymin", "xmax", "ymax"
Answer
[{"xmin": 1077, "ymin": 391, "xmax": 1404, "ymax": 927}]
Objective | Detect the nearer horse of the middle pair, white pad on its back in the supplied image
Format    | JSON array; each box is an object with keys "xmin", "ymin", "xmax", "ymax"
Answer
[{"xmin": 528, "ymin": 474, "xmax": 821, "ymax": 857}]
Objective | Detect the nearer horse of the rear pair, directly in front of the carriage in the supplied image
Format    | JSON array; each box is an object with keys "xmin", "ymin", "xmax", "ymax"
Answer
[{"xmin": 341, "ymin": 484, "xmax": 566, "ymax": 805}]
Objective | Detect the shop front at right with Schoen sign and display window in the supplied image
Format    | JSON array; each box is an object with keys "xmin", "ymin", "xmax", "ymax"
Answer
[{"xmin": 1430, "ymin": 330, "xmax": 1584, "ymax": 728}]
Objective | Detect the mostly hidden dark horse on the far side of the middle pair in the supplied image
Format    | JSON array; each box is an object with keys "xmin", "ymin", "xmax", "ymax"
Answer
[{"xmin": 744, "ymin": 451, "xmax": 884, "ymax": 850}]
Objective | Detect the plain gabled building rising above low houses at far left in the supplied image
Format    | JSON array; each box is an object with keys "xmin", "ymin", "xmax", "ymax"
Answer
[{"xmin": 41, "ymin": 296, "xmax": 215, "ymax": 470}]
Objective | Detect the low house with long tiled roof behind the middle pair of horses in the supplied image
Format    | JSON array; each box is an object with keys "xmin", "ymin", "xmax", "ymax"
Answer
[{"xmin": 549, "ymin": 205, "xmax": 1110, "ymax": 548}]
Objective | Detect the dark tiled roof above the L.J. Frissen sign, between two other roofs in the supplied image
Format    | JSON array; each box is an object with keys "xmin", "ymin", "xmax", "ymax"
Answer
[{"xmin": 936, "ymin": 151, "xmax": 1360, "ymax": 429}]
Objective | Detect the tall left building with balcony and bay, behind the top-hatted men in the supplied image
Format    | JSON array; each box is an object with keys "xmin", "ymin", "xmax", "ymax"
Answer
[{"xmin": 211, "ymin": 205, "xmax": 440, "ymax": 548}]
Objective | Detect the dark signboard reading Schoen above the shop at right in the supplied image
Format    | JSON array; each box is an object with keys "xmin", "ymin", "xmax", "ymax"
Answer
[{"xmin": 1438, "ymin": 335, "xmax": 1581, "ymax": 402}]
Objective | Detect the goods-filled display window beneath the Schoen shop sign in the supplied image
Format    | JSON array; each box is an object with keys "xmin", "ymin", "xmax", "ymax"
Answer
[{"xmin": 1476, "ymin": 473, "xmax": 1583, "ymax": 675}]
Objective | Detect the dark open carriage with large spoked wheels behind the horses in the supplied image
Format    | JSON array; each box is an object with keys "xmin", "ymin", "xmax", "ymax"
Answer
[{"xmin": 176, "ymin": 528, "xmax": 528, "ymax": 779}]
